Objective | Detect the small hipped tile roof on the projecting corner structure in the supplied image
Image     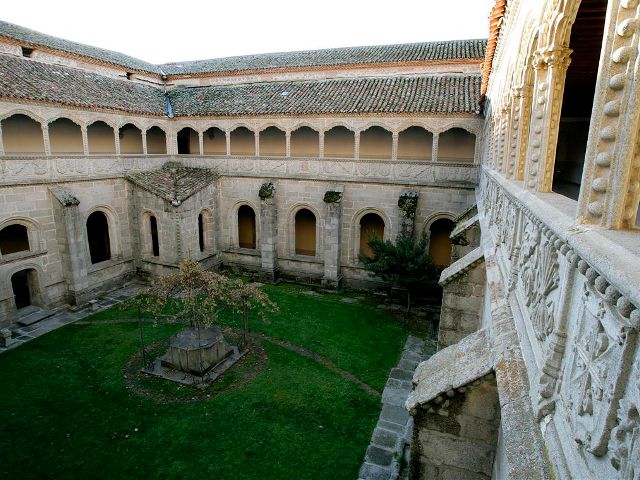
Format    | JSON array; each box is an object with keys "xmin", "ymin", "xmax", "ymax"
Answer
[{"xmin": 126, "ymin": 162, "xmax": 218, "ymax": 207}]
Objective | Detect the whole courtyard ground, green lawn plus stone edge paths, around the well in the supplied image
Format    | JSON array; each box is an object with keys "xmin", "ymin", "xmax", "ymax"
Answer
[{"xmin": 0, "ymin": 276, "xmax": 432, "ymax": 479}]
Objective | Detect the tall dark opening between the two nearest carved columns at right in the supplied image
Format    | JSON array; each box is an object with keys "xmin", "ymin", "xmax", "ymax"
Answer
[{"xmin": 552, "ymin": 0, "xmax": 607, "ymax": 200}]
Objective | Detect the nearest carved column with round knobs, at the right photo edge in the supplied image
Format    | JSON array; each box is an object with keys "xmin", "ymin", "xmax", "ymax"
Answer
[{"xmin": 578, "ymin": 1, "xmax": 640, "ymax": 229}]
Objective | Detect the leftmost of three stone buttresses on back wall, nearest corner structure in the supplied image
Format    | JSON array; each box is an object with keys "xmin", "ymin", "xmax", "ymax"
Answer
[{"xmin": 258, "ymin": 182, "xmax": 278, "ymax": 283}]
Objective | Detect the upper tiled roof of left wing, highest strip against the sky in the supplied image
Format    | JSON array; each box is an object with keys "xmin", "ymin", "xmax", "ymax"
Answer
[{"xmin": 0, "ymin": 20, "xmax": 161, "ymax": 74}]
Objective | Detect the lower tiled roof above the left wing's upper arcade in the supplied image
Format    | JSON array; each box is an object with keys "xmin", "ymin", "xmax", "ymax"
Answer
[{"xmin": 0, "ymin": 55, "xmax": 167, "ymax": 115}]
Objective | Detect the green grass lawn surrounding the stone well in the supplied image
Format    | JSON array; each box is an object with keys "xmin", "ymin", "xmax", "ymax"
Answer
[{"xmin": 0, "ymin": 285, "xmax": 407, "ymax": 480}]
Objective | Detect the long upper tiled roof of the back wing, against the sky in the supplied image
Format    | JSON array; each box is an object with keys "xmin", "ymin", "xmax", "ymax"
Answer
[{"xmin": 160, "ymin": 40, "xmax": 487, "ymax": 75}]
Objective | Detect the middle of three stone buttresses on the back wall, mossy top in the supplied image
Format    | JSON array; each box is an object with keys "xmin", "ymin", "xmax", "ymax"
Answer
[{"xmin": 322, "ymin": 186, "xmax": 344, "ymax": 288}]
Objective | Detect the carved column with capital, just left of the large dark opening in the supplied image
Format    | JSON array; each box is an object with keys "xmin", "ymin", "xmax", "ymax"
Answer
[{"xmin": 524, "ymin": 47, "xmax": 572, "ymax": 192}]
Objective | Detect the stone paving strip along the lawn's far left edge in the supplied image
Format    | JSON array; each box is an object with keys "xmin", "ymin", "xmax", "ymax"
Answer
[{"xmin": 0, "ymin": 281, "xmax": 143, "ymax": 353}]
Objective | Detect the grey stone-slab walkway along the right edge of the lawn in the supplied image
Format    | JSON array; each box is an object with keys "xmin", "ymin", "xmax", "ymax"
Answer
[{"xmin": 359, "ymin": 336, "xmax": 427, "ymax": 480}]
